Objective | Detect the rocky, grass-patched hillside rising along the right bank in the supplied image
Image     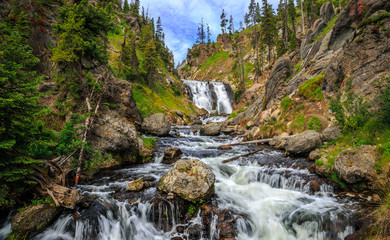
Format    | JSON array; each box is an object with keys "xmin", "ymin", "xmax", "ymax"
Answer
[{"xmin": 179, "ymin": 0, "xmax": 390, "ymax": 239}]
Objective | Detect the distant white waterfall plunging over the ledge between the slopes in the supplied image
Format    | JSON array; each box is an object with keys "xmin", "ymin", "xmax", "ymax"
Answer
[{"xmin": 183, "ymin": 80, "xmax": 233, "ymax": 114}]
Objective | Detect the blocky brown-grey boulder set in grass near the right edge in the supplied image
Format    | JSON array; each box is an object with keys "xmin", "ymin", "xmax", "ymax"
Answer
[{"xmin": 334, "ymin": 145, "xmax": 377, "ymax": 183}]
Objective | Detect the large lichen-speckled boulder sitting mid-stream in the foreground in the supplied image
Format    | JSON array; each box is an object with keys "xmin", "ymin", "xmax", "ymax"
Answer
[{"xmin": 157, "ymin": 159, "xmax": 215, "ymax": 202}]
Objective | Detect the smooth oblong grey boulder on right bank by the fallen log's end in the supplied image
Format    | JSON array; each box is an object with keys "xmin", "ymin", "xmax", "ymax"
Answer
[{"xmin": 285, "ymin": 130, "xmax": 322, "ymax": 155}]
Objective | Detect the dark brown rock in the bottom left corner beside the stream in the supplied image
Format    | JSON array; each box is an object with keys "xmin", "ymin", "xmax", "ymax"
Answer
[{"xmin": 11, "ymin": 204, "xmax": 61, "ymax": 235}]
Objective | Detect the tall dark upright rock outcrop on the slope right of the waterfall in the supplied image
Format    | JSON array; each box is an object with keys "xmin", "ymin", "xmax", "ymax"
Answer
[{"xmin": 265, "ymin": 58, "xmax": 292, "ymax": 108}]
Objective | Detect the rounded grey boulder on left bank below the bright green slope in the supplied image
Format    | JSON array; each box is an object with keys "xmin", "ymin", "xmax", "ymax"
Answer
[{"xmin": 142, "ymin": 113, "xmax": 172, "ymax": 137}]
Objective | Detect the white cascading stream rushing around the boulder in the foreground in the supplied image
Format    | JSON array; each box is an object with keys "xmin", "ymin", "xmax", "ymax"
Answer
[{"xmin": 1, "ymin": 127, "xmax": 356, "ymax": 240}]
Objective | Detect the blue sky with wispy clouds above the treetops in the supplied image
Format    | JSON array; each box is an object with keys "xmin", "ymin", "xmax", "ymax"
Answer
[{"xmin": 140, "ymin": 0, "xmax": 279, "ymax": 64}]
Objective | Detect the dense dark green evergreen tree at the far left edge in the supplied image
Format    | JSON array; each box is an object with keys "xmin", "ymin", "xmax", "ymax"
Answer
[{"xmin": 0, "ymin": 15, "xmax": 42, "ymax": 206}]
